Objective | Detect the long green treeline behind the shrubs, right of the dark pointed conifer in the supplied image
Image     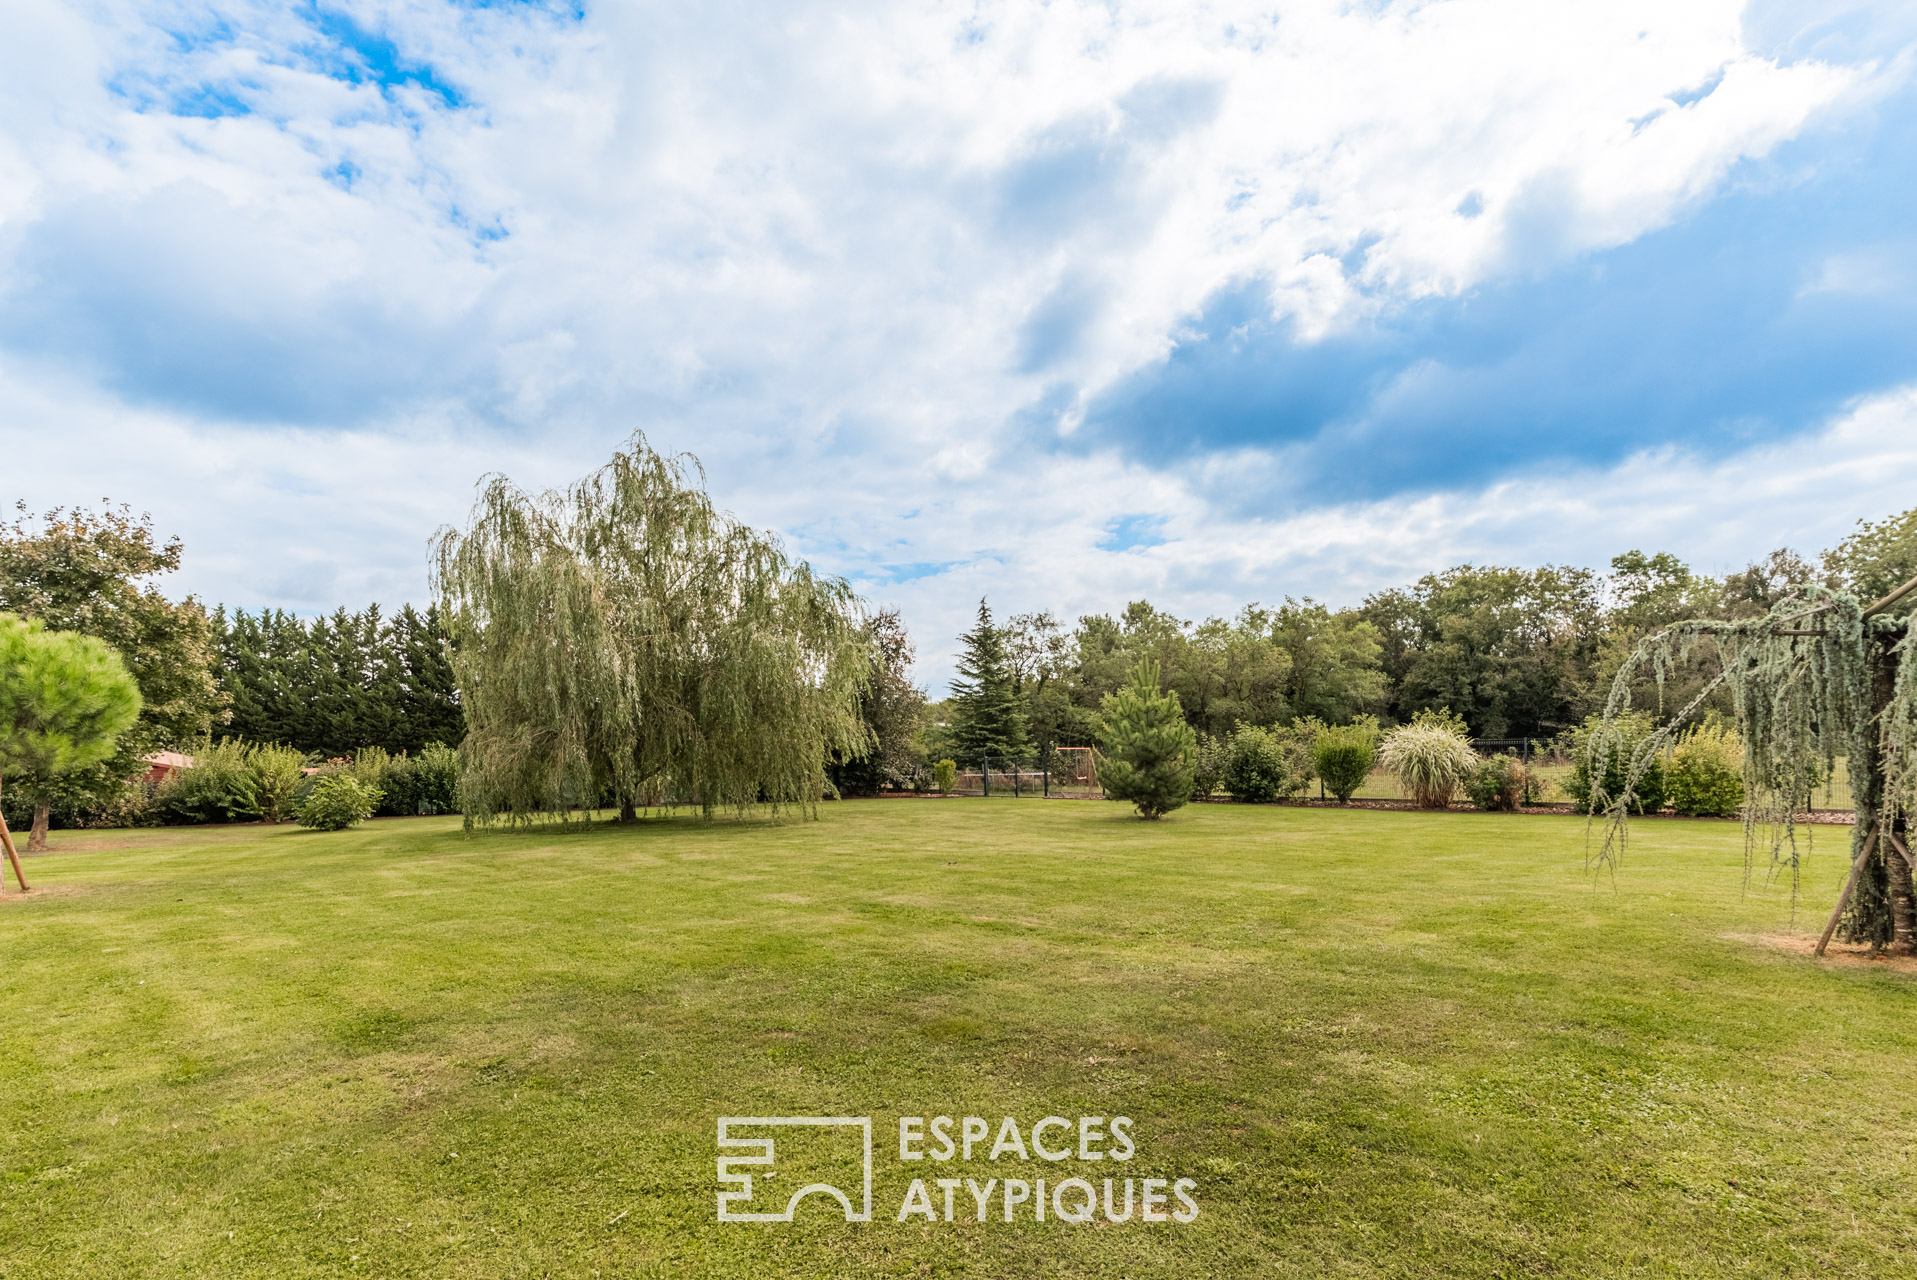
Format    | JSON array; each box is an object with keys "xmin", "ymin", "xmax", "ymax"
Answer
[{"xmin": 916, "ymin": 510, "xmax": 1917, "ymax": 770}]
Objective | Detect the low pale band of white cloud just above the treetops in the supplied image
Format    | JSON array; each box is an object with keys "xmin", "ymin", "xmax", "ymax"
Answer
[{"xmin": 0, "ymin": 346, "xmax": 1917, "ymax": 688}]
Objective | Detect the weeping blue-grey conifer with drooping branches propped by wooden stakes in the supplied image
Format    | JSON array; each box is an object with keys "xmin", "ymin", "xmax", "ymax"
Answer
[{"xmin": 1585, "ymin": 579, "xmax": 1917, "ymax": 956}]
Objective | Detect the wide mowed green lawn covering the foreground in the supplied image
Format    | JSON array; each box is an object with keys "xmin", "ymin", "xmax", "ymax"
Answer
[{"xmin": 0, "ymin": 799, "xmax": 1917, "ymax": 1278}]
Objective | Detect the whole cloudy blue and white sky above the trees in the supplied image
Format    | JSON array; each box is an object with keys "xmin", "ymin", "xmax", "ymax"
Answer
[{"xmin": 0, "ymin": 0, "xmax": 1917, "ymax": 692}]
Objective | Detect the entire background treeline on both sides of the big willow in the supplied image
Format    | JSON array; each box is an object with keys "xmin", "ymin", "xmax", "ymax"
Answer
[{"xmin": 14, "ymin": 494, "xmax": 1917, "ymax": 816}]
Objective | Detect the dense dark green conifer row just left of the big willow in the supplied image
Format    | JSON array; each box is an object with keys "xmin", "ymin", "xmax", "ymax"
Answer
[{"xmin": 213, "ymin": 606, "xmax": 466, "ymax": 757}]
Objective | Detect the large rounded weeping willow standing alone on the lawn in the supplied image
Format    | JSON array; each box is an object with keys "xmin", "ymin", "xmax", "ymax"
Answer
[{"xmin": 433, "ymin": 435, "xmax": 868, "ymax": 826}]
